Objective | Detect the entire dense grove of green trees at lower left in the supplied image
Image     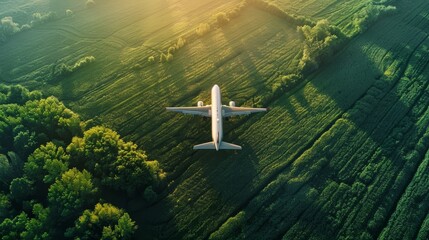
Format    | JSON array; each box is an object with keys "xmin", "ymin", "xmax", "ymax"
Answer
[{"xmin": 0, "ymin": 84, "xmax": 164, "ymax": 239}]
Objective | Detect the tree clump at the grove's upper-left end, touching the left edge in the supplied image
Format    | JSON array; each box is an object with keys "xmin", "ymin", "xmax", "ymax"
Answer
[{"xmin": 0, "ymin": 89, "xmax": 84, "ymax": 160}]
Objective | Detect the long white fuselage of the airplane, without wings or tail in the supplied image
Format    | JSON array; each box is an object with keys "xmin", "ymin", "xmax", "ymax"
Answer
[{"xmin": 211, "ymin": 85, "xmax": 223, "ymax": 150}]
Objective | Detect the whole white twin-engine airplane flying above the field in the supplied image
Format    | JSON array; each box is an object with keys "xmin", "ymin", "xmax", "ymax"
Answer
[{"xmin": 167, "ymin": 85, "xmax": 267, "ymax": 151}]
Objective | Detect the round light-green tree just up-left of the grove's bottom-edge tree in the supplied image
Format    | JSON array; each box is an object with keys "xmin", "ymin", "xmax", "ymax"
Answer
[{"xmin": 48, "ymin": 168, "xmax": 98, "ymax": 222}]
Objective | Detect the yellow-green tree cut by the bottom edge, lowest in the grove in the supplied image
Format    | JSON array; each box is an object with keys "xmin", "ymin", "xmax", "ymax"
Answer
[{"xmin": 65, "ymin": 203, "xmax": 137, "ymax": 239}]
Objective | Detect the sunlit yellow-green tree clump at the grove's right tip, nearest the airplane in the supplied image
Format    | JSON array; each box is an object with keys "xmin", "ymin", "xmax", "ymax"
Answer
[{"xmin": 67, "ymin": 127, "xmax": 161, "ymax": 193}]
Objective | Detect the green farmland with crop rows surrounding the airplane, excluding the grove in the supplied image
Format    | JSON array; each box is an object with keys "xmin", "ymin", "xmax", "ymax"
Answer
[{"xmin": 0, "ymin": 0, "xmax": 429, "ymax": 239}]
